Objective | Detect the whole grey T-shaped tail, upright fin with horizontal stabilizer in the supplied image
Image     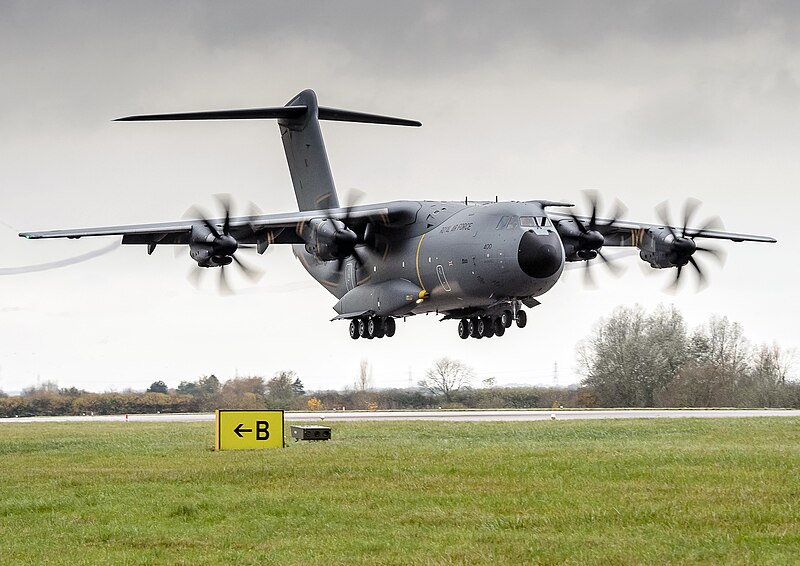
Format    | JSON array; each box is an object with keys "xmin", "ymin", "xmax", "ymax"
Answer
[{"xmin": 117, "ymin": 89, "xmax": 422, "ymax": 210}]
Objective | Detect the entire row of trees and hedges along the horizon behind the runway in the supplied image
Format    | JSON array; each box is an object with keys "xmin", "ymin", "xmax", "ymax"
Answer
[{"xmin": 0, "ymin": 305, "xmax": 800, "ymax": 417}]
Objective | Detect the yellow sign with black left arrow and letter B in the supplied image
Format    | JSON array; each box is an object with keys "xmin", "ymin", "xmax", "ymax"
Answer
[{"xmin": 214, "ymin": 410, "xmax": 283, "ymax": 450}]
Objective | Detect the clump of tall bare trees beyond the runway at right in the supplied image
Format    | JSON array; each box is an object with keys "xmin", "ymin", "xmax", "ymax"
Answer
[{"xmin": 578, "ymin": 305, "xmax": 800, "ymax": 407}]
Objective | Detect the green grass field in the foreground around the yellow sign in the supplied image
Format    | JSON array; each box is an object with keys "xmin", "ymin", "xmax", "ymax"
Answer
[{"xmin": 0, "ymin": 418, "xmax": 800, "ymax": 565}]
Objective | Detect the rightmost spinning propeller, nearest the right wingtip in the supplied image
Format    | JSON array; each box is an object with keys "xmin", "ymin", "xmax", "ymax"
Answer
[{"xmin": 656, "ymin": 198, "xmax": 726, "ymax": 291}]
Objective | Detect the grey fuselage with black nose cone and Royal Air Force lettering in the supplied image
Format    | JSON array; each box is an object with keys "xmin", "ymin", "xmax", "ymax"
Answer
[{"xmin": 293, "ymin": 201, "xmax": 564, "ymax": 320}]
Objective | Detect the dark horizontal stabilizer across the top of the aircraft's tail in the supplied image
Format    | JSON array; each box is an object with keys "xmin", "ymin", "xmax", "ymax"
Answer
[{"xmin": 114, "ymin": 105, "xmax": 422, "ymax": 126}]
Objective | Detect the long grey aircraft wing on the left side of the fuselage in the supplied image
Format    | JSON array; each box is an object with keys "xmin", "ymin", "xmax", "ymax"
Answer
[{"xmin": 19, "ymin": 203, "xmax": 409, "ymax": 247}]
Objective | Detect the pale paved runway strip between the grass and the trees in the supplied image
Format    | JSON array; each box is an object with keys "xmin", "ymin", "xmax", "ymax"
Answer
[{"xmin": 0, "ymin": 409, "xmax": 800, "ymax": 425}]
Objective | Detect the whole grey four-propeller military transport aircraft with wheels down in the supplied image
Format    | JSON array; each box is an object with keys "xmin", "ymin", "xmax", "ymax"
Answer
[{"xmin": 20, "ymin": 90, "xmax": 776, "ymax": 339}]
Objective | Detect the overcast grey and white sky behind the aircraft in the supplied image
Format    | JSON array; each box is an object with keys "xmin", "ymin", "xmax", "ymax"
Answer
[{"xmin": 0, "ymin": 0, "xmax": 800, "ymax": 391}]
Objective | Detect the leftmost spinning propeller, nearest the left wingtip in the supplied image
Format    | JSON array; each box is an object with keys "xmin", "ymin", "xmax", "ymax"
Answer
[{"xmin": 186, "ymin": 194, "xmax": 264, "ymax": 295}]
